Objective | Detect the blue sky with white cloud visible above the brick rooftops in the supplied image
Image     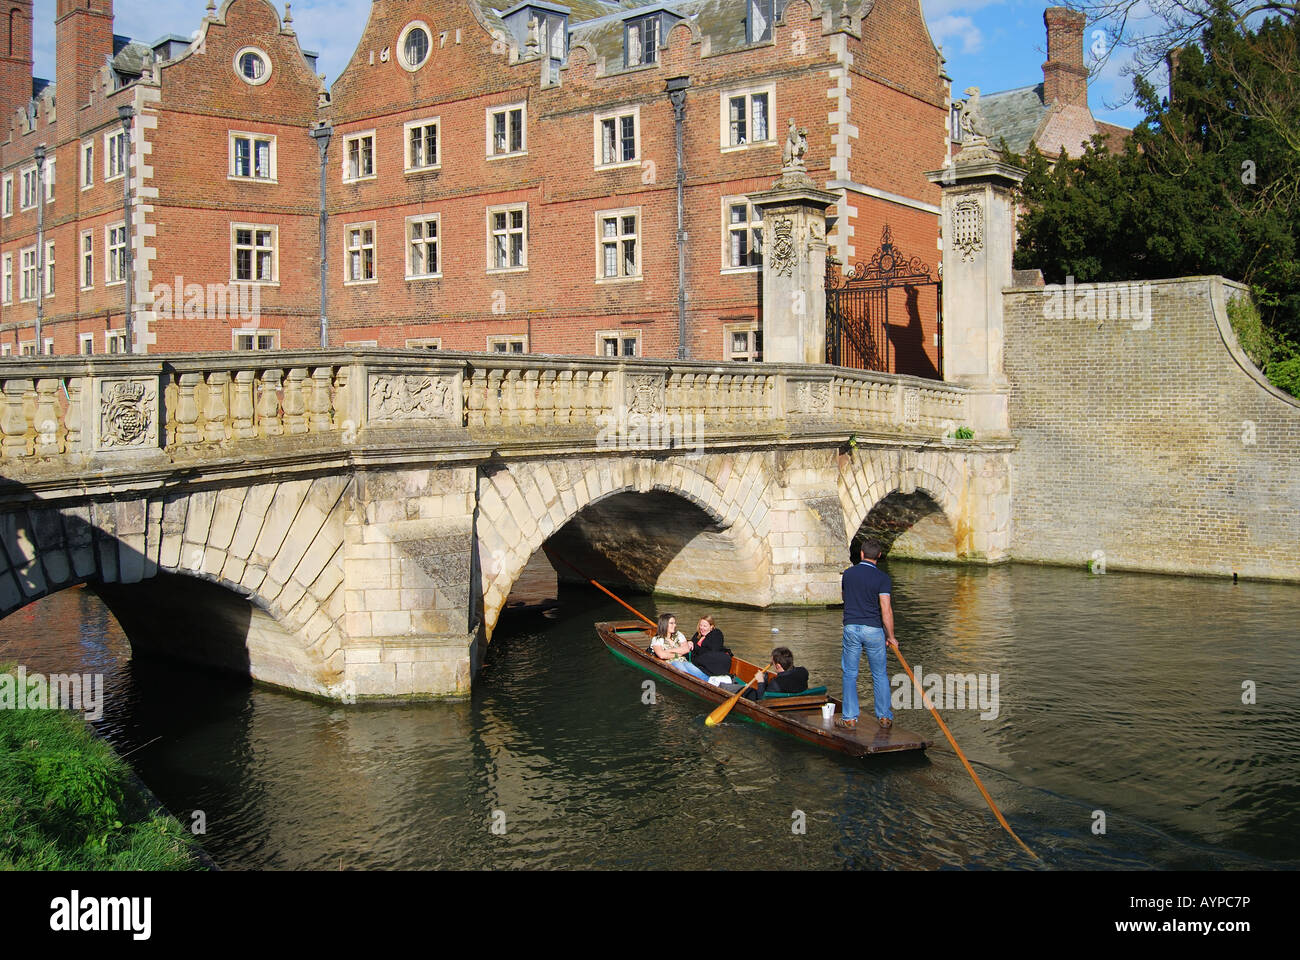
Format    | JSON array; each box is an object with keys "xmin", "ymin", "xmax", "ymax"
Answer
[{"xmin": 27, "ymin": 0, "xmax": 1140, "ymax": 126}]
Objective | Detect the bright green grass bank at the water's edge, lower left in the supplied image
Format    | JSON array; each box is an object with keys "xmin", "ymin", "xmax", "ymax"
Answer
[{"xmin": 0, "ymin": 666, "xmax": 200, "ymax": 870}]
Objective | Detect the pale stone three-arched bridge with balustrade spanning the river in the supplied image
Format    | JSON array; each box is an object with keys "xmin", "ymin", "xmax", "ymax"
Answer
[{"xmin": 0, "ymin": 350, "xmax": 1014, "ymax": 700}]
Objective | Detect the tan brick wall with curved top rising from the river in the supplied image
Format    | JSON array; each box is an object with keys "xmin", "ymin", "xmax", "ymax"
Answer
[{"xmin": 1004, "ymin": 277, "xmax": 1300, "ymax": 580}]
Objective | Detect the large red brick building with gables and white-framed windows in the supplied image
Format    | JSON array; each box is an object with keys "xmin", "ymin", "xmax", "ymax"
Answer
[{"xmin": 0, "ymin": 0, "xmax": 949, "ymax": 363}]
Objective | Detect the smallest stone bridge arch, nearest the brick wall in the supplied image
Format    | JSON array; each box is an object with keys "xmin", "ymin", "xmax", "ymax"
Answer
[{"xmin": 837, "ymin": 447, "xmax": 971, "ymax": 558}]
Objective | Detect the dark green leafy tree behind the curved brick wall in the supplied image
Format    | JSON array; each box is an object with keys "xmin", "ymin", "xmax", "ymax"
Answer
[{"xmin": 1015, "ymin": 3, "xmax": 1300, "ymax": 355}]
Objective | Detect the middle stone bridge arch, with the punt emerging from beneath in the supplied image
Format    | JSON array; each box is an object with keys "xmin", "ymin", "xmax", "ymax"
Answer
[{"xmin": 478, "ymin": 454, "xmax": 772, "ymax": 636}]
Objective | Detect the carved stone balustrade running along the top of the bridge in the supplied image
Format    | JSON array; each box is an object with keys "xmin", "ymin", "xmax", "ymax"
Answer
[{"xmin": 0, "ymin": 350, "xmax": 970, "ymax": 472}]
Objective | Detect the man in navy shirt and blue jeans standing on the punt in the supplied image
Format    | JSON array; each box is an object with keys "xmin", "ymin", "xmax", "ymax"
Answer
[{"xmin": 835, "ymin": 539, "xmax": 898, "ymax": 730}]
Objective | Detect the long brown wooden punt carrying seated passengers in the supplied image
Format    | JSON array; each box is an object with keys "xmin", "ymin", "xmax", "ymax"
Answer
[{"xmin": 595, "ymin": 620, "xmax": 933, "ymax": 757}]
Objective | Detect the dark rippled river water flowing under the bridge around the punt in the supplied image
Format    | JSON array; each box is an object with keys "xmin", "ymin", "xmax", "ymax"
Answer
[{"xmin": 0, "ymin": 561, "xmax": 1300, "ymax": 869}]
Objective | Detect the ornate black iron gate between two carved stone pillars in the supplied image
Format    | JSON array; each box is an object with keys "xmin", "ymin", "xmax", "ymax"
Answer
[{"xmin": 826, "ymin": 224, "xmax": 944, "ymax": 376}]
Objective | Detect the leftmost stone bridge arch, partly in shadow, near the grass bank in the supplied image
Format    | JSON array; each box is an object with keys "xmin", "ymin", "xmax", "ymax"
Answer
[{"xmin": 0, "ymin": 476, "xmax": 347, "ymax": 696}]
